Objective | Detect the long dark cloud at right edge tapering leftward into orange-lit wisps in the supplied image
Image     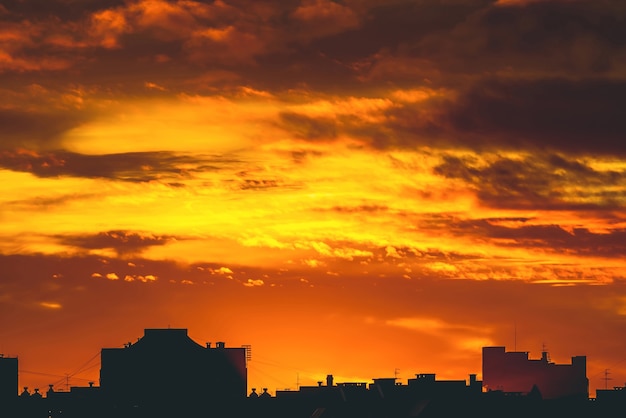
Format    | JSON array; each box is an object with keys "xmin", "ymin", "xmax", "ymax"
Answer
[{"xmin": 280, "ymin": 78, "xmax": 626, "ymax": 156}]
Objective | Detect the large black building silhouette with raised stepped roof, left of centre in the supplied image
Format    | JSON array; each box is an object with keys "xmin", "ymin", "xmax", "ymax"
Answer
[{"xmin": 100, "ymin": 328, "xmax": 247, "ymax": 410}]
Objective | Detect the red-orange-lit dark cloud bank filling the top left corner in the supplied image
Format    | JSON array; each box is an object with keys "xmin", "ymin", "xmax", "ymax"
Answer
[{"xmin": 0, "ymin": 0, "xmax": 359, "ymax": 82}]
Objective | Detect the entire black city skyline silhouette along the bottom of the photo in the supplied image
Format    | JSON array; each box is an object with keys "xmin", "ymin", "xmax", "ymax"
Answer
[{"xmin": 0, "ymin": 328, "xmax": 626, "ymax": 418}]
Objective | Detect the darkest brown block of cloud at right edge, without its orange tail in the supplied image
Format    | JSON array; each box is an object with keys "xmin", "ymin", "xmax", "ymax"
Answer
[{"xmin": 442, "ymin": 79, "xmax": 626, "ymax": 155}]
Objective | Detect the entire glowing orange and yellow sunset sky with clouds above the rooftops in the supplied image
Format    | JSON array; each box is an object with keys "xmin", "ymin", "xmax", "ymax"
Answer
[{"xmin": 0, "ymin": 0, "xmax": 626, "ymax": 396}]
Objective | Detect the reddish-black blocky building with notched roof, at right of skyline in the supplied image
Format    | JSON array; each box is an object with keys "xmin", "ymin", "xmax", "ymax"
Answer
[{"xmin": 483, "ymin": 347, "xmax": 589, "ymax": 399}]
